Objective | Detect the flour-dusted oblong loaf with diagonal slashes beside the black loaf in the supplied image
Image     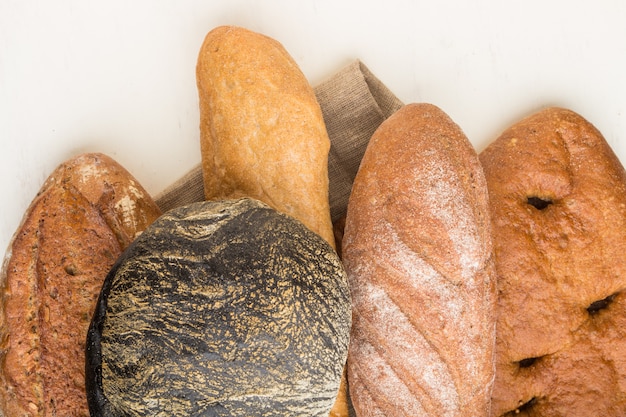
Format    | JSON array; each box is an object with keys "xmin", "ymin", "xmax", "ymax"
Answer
[{"xmin": 343, "ymin": 104, "xmax": 495, "ymax": 417}]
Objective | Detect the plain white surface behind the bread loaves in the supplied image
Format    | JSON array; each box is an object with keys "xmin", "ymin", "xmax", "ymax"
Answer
[{"xmin": 0, "ymin": 0, "xmax": 626, "ymax": 251}]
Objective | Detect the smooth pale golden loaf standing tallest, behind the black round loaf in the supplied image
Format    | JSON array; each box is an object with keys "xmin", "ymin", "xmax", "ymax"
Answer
[{"xmin": 196, "ymin": 26, "xmax": 348, "ymax": 417}]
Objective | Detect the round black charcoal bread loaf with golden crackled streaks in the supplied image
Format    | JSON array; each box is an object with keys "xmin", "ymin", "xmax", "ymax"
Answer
[{"xmin": 87, "ymin": 198, "xmax": 351, "ymax": 417}]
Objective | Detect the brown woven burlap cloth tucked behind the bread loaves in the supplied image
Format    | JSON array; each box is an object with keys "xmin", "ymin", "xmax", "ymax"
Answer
[{"xmin": 155, "ymin": 60, "xmax": 403, "ymax": 222}]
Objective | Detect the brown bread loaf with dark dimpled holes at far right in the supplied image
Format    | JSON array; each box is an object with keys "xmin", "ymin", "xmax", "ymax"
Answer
[{"xmin": 480, "ymin": 108, "xmax": 626, "ymax": 417}]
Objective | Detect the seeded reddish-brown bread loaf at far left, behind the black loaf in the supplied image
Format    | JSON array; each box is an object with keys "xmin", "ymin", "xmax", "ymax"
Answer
[{"xmin": 0, "ymin": 154, "xmax": 160, "ymax": 417}]
